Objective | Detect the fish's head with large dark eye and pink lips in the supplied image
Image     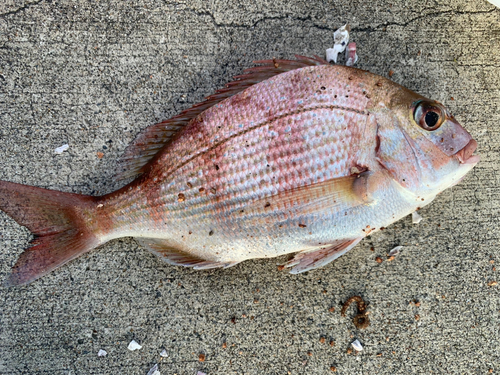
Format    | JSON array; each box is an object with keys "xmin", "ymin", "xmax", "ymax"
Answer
[{"xmin": 375, "ymin": 88, "xmax": 480, "ymax": 200}]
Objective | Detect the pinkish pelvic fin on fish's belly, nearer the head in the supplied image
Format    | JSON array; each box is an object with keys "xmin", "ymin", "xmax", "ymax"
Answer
[{"xmin": 285, "ymin": 237, "xmax": 363, "ymax": 274}]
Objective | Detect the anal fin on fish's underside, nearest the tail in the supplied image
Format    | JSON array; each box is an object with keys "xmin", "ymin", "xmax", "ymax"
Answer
[{"xmin": 135, "ymin": 237, "xmax": 239, "ymax": 270}]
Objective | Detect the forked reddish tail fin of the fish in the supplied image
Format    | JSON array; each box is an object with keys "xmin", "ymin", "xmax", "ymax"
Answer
[{"xmin": 0, "ymin": 181, "xmax": 99, "ymax": 286}]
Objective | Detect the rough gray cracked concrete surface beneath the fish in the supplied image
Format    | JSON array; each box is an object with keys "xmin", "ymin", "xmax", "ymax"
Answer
[{"xmin": 0, "ymin": 0, "xmax": 500, "ymax": 375}]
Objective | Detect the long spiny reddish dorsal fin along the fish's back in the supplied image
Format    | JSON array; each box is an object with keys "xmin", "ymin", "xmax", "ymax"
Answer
[{"xmin": 117, "ymin": 55, "xmax": 328, "ymax": 179}]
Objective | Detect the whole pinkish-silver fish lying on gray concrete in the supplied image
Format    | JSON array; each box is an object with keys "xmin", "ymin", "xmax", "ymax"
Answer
[{"xmin": 0, "ymin": 55, "xmax": 480, "ymax": 287}]
